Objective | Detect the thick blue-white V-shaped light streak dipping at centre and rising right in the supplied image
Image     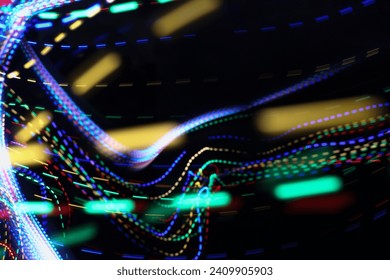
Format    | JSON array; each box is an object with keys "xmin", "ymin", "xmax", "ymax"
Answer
[{"xmin": 23, "ymin": 40, "xmax": 345, "ymax": 169}]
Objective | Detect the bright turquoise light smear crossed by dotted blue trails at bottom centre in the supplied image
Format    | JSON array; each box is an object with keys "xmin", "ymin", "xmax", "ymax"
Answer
[{"xmin": 173, "ymin": 192, "xmax": 232, "ymax": 210}]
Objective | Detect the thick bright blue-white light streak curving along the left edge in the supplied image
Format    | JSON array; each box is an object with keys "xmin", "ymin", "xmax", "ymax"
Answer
[{"xmin": 0, "ymin": 0, "xmax": 71, "ymax": 259}]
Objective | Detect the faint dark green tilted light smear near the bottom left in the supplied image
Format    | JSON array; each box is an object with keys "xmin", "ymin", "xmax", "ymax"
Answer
[{"xmin": 52, "ymin": 224, "xmax": 98, "ymax": 246}]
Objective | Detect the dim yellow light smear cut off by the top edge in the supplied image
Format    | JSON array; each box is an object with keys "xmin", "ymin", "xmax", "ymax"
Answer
[{"xmin": 153, "ymin": 0, "xmax": 222, "ymax": 37}]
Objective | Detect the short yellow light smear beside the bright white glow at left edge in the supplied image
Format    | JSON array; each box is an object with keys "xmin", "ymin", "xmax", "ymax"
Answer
[{"xmin": 8, "ymin": 143, "xmax": 50, "ymax": 166}]
